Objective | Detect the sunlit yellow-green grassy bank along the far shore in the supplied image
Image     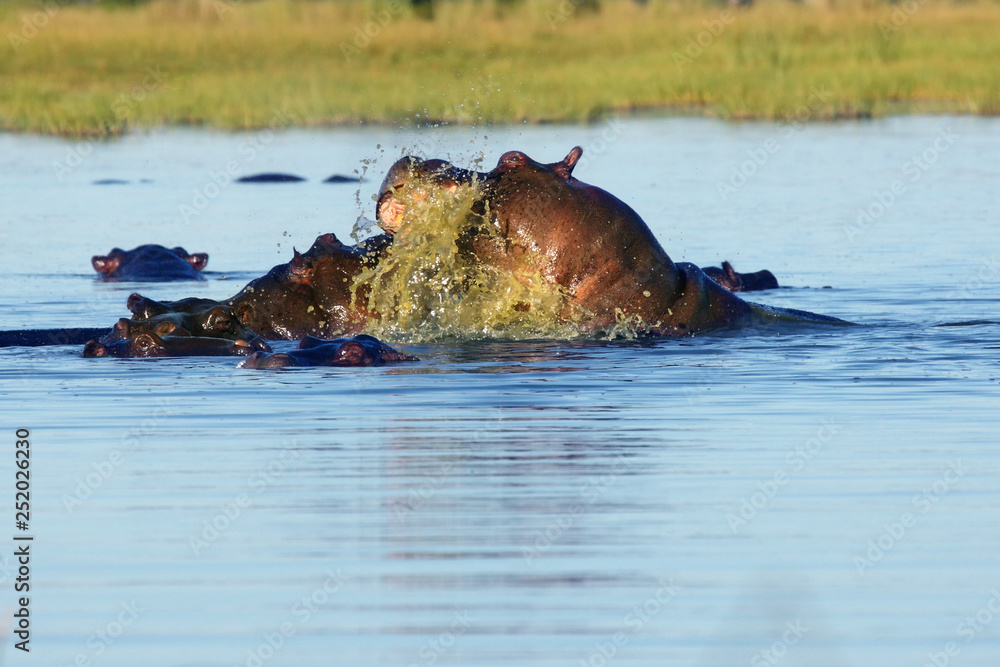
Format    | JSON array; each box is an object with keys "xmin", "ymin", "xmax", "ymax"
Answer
[{"xmin": 0, "ymin": 0, "xmax": 1000, "ymax": 135}]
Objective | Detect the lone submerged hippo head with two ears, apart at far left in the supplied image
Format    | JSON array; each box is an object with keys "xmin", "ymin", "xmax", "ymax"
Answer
[{"xmin": 90, "ymin": 244, "xmax": 208, "ymax": 282}]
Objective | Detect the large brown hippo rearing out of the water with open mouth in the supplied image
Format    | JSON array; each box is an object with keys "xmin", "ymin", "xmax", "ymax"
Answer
[{"xmin": 377, "ymin": 146, "xmax": 842, "ymax": 336}]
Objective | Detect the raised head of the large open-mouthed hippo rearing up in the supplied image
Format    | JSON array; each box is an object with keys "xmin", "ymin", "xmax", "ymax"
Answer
[{"xmin": 377, "ymin": 147, "xmax": 681, "ymax": 327}]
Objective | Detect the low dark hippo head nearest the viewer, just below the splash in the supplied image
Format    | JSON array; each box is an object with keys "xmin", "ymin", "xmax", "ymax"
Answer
[{"xmin": 240, "ymin": 334, "xmax": 418, "ymax": 368}]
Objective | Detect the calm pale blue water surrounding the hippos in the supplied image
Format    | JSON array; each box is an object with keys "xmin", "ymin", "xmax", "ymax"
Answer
[{"xmin": 0, "ymin": 117, "xmax": 1000, "ymax": 667}]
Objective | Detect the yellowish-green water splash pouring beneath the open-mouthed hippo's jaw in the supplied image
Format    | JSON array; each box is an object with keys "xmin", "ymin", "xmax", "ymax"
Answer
[{"xmin": 352, "ymin": 184, "xmax": 584, "ymax": 342}]
